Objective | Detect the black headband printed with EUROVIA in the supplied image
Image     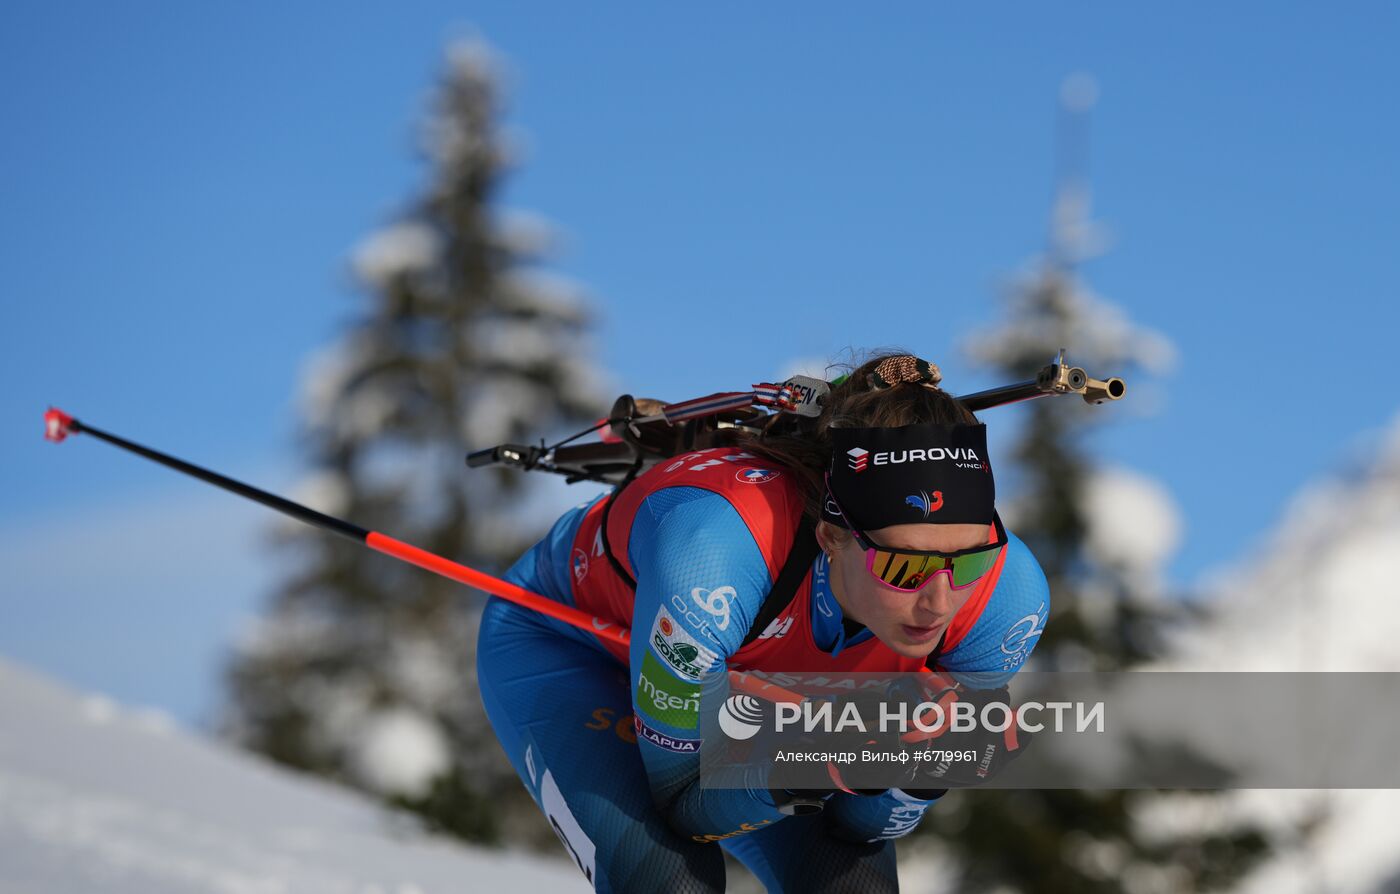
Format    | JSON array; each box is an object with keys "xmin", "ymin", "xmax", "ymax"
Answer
[{"xmin": 822, "ymin": 424, "xmax": 997, "ymax": 530}]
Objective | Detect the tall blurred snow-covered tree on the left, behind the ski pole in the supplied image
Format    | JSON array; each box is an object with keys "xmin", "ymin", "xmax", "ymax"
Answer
[{"xmin": 227, "ymin": 42, "xmax": 606, "ymax": 839}]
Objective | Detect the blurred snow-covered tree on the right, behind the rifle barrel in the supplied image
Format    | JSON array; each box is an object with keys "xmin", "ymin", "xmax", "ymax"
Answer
[{"xmin": 928, "ymin": 77, "xmax": 1266, "ymax": 894}]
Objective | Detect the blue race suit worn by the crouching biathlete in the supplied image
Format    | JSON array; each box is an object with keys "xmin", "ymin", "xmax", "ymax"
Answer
[{"xmin": 477, "ymin": 449, "xmax": 1050, "ymax": 893}]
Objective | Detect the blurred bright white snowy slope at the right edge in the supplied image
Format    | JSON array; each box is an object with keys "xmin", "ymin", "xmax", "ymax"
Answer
[{"xmin": 1163, "ymin": 417, "xmax": 1400, "ymax": 894}]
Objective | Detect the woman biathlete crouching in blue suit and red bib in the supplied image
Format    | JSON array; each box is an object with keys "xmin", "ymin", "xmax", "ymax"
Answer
[{"xmin": 477, "ymin": 355, "xmax": 1050, "ymax": 893}]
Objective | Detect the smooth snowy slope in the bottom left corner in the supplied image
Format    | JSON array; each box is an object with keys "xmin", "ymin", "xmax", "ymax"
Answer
[{"xmin": 0, "ymin": 660, "xmax": 588, "ymax": 894}]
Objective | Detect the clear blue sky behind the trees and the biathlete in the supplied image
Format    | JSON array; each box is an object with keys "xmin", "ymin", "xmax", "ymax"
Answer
[{"xmin": 0, "ymin": 3, "xmax": 1400, "ymax": 719}]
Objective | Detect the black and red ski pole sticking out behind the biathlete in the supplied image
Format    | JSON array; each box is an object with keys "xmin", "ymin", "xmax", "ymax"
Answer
[{"xmin": 43, "ymin": 407, "xmax": 802, "ymax": 702}]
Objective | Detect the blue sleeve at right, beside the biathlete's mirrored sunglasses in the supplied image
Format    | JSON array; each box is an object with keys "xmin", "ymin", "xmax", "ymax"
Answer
[{"xmin": 938, "ymin": 533, "xmax": 1050, "ymax": 688}]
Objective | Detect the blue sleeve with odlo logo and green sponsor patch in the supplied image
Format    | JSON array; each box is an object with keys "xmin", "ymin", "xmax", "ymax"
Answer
[{"xmin": 627, "ymin": 487, "xmax": 783, "ymax": 837}]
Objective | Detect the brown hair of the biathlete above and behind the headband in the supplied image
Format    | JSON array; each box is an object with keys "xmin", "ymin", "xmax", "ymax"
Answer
[{"xmin": 739, "ymin": 353, "xmax": 977, "ymax": 520}]
